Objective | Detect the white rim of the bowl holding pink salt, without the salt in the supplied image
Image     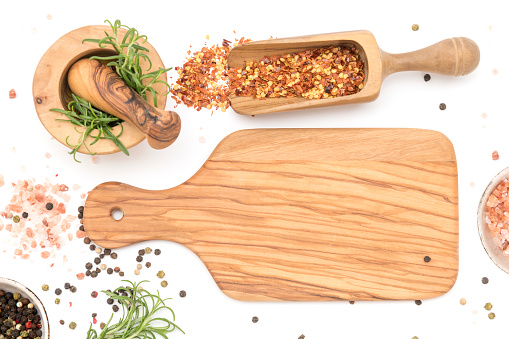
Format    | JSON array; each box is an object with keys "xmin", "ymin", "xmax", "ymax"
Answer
[{"xmin": 477, "ymin": 167, "xmax": 509, "ymax": 273}]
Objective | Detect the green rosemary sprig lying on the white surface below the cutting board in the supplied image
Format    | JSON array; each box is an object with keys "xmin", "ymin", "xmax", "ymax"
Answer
[{"xmin": 87, "ymin": 280, "xmax": 184, "ymax": 339}]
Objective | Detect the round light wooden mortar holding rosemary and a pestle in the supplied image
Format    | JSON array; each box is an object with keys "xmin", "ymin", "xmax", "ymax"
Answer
[{"xmin": 32, "ymin": 25, "xmax": 167, "ymax": 154}]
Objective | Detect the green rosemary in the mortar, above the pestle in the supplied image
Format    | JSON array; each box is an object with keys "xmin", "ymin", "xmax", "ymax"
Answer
[{"xmin": 83, "ymin": 20, "xmax": 172, "ymax": 107}]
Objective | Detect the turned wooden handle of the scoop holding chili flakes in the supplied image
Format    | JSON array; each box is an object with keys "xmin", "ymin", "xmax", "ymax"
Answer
[{"xmin": 380, "ymin": 37, "xmax": 480, "ymax": 78}]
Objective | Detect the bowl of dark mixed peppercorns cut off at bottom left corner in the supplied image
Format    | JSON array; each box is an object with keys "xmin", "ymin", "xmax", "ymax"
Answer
[{"xmin": 0, "ymin": 277, "xmax": 49, "ymax": 339}]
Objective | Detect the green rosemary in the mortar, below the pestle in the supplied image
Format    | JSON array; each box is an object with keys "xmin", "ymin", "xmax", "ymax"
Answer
[{"xmin": 50, "ymin": 94, "xmax": 129, "ymax": 162}]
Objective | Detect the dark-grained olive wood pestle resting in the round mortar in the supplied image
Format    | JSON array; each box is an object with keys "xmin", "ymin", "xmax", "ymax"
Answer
[{"xmin": 68, "ymin": 59, "xmax": 180, "ymax": 149}]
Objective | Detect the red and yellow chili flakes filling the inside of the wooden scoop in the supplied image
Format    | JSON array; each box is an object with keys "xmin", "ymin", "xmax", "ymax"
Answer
[{"xmin": 228, "ymin": 45, "xmax": 364, "ymax": 99}]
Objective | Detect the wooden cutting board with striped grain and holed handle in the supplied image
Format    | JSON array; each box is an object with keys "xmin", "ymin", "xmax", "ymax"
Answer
[{"xmin": 83, "ymin": 129, "xmax": 458, "ymax": 301}]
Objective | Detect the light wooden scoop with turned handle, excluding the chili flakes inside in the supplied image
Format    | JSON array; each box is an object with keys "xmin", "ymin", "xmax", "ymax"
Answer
[{"xmin": 228, "ymin": 31, "xmax": 480, "ymax": 115}]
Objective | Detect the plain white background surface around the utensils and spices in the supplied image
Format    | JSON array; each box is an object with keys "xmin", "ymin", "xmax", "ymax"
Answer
[{"xmin": 0, "ymin": 1, "xmax": 509, "ymax": 339}]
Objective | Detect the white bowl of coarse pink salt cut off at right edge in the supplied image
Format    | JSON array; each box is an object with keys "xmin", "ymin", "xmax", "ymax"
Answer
[{"xmin": 477, "ymin": 167, "xmax": 509, "ymax": 273}]
